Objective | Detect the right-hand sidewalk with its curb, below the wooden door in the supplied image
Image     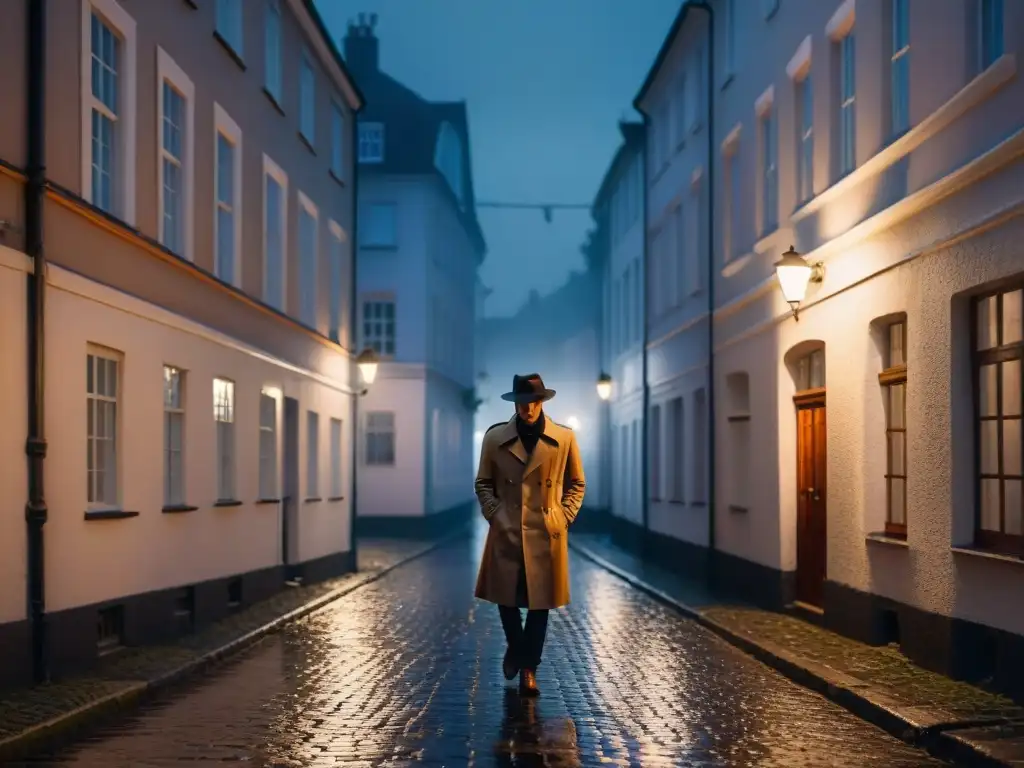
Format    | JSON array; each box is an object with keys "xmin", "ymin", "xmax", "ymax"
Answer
[{"xmin": 569, "ymin": 532, "xmax": 1024, "ymax": 766}]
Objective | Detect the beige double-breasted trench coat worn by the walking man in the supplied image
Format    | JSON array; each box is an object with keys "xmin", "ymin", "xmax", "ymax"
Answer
[{"xmin": 476, "ymin": 417, "xmax": 586, "ymax": 609}]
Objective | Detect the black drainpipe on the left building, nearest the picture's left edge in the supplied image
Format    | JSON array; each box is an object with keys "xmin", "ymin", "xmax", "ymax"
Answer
[{"xmin": 25, "ymin": 0, "xmax": 49, "ymax": 683}]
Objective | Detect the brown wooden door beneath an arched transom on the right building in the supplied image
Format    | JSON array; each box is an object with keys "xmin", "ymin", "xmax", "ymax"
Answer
[{"xmin": 797, "ymin": 402, "xmax": 827, "ymax": 607}]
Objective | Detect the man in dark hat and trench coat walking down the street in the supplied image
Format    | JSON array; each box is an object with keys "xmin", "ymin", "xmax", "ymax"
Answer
[{"xmin": 476, "ymin": 374, "xmax": 586, "ymax": 696}]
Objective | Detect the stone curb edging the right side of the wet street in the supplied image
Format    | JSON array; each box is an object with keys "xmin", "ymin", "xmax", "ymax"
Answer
[{"xmin": 569, "ymin": 543, "xmax": 1012, "ymax": 768}]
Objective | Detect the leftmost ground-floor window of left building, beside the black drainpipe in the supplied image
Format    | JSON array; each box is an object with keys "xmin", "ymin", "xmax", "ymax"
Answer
[{"xmin": 85, "ymin": 349, "xmax": 121, "ymax": 509}]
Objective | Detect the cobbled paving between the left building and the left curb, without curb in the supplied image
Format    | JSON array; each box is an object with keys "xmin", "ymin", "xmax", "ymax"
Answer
[{"xmin": 0, "ymin": 540, "xmax": 438, "ymax": 742}]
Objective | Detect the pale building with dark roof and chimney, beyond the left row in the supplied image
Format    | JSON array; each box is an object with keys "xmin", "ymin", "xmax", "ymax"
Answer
[{"xmin": 345, "ymin": 16, "xmax": 485, "ymax": 535}]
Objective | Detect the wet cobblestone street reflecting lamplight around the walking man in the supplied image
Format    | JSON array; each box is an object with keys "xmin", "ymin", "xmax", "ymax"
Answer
[{"xmin": 19, "ymin": 540, "xmax": 941, "ymax": 768}]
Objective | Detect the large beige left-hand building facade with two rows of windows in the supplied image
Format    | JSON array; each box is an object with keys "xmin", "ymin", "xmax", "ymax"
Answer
[{"xmin": 0, "ymin": 0, "xmax": 361, "ymax": 683}]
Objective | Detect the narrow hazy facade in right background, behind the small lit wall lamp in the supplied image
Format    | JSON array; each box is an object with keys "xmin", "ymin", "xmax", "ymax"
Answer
[{"xmin": 587, "ymin": 122, "xmax": 644, "ymax": 525}]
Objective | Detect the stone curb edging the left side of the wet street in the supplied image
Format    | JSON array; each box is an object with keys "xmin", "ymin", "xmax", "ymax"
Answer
[{"xmin": 0, "ymin": 524, "xmax": 468, "ymax": 764}]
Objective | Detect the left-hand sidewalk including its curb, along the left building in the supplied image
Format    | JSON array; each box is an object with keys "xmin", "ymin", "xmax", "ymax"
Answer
[{"xmin": 0, "ymin": 530, "xmax": 463, "ymax": 764}]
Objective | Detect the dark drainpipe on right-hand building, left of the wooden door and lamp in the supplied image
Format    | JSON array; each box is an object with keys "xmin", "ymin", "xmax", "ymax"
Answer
[{"xmin": 690, "ymin": 0, "xmax": 718, "ymax": 585}]
